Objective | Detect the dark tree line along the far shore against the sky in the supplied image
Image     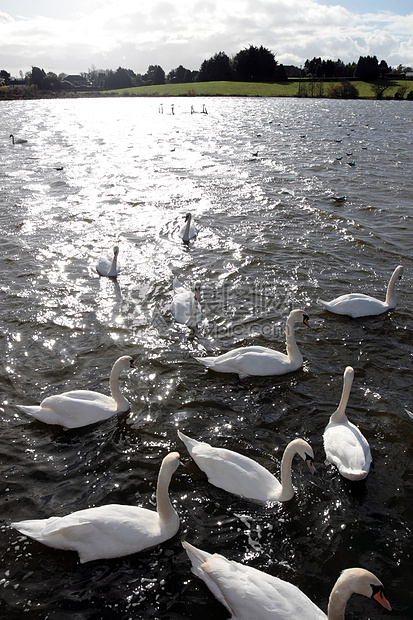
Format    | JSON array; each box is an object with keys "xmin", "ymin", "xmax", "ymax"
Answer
[{"xmin": 0, "ymin": 45, "xmax": 411, "ymax": 91}]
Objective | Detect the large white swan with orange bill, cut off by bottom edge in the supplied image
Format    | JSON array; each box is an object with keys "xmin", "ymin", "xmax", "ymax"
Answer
[{"xmin": 182, "ymin": 541, "xmax": 391, "ymax": 620}]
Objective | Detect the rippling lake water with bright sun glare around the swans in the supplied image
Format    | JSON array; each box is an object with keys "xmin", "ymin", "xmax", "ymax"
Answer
[{"xmin": 0, "ymin": 98, "xmax": 413, "ymax": 620}]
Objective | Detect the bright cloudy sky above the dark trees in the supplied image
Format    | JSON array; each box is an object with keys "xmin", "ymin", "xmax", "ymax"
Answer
[{"xmin": 0, "ymin": 0, "xmax": 413, "ymax": 76}]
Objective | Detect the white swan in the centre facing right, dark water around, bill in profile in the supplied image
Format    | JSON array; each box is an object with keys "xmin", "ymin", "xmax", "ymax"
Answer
[{"xmin": 195, "ymin": 310, "xmax": 310, "ymax": 379}]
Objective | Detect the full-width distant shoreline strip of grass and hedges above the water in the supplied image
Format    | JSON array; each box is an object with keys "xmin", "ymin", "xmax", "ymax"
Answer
[{"xmin": 0, "ymin": 78, "xmax": 413, "ymax": 101}]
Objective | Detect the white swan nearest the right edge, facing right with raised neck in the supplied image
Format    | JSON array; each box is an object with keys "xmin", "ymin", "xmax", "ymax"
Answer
[{"xmin": 318, "ymin": 265, "xmax": 403, "ymax": 319}]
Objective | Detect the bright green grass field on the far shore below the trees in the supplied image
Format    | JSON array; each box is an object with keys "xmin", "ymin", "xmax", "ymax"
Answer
[{"xmin": 101, "ymin": 80, "xmax": 413, "ymax": 99}]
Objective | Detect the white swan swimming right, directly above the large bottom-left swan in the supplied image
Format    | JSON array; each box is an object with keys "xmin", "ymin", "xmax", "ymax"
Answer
[{"xmin": 17, "ymin": 355, "xmax": 136, "ymax": 428}]
